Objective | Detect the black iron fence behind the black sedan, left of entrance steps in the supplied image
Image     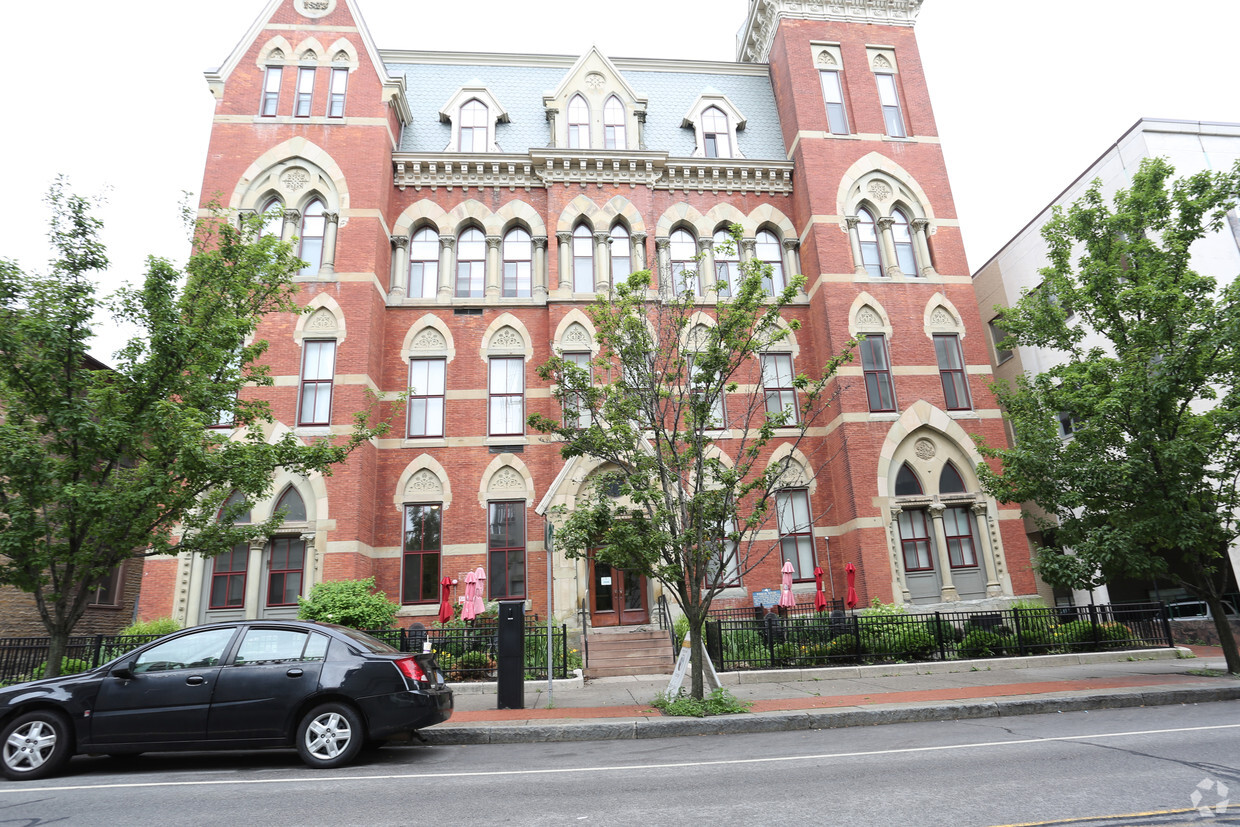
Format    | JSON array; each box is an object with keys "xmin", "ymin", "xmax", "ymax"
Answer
[{"xmin": 0, "ymin": 620, "xmax": 568, "ymax": 684}]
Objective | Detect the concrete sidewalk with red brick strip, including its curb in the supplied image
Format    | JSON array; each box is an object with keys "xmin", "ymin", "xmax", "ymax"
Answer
[{"xmin": 420, "ymin": 647, "xmax": 1240, "ymax": 744}]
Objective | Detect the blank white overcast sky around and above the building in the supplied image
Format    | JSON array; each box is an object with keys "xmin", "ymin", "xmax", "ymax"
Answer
[{"xmin": 9, "ymin": 0, "xmax": 1240, "ymax": 361}]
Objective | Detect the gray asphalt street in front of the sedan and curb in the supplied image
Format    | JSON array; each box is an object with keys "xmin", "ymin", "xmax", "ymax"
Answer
[{"xmin": 0, "ymin": 702, "xmax": 1240, "ymax": 827}]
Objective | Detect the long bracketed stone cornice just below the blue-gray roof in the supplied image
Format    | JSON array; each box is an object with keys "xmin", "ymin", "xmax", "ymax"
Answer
[{"xmin": 393, "ymin": 149, "xmax": 794, "ymax": 195}]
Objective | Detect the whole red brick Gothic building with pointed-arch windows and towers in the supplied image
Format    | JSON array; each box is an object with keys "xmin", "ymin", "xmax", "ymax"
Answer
[{"xmin": 141, "ymin": 0, "xmax": 1035, "ymax": 625}]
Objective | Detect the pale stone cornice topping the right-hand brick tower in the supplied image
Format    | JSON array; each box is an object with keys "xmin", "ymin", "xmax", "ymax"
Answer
[{"xmin": 737, "ymin": 0, "xmax": 921, "ymax": 63}]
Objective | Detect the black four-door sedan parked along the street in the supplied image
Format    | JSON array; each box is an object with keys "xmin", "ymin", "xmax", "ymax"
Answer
[{"xmin": 0, "ymin": 620, "xmax": 453, "ymax": 779}]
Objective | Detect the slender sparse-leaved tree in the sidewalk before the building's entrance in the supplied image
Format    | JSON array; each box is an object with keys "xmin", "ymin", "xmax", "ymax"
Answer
[{"xmin": 529, "ymin": 226, "xmax": 849, "ymax": 699}]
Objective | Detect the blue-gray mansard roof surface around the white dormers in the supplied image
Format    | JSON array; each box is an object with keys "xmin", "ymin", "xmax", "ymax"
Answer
[{"xmin": 387, "ymin": 62, "xmax": 787, "ymax": 160}]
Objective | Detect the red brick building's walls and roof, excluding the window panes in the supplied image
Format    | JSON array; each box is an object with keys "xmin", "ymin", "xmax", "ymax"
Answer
[{"xmin": 141, "ymin": 0, "xmax": 1034, "ymax": 624}]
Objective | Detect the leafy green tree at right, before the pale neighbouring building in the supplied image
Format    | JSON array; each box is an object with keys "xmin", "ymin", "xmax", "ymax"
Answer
[{"xmin": 980, "ymin": 154, "xmax": 1240, "ymax": 672}]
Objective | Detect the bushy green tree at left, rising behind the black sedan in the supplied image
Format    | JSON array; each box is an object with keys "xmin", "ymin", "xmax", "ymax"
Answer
[{"xmin": 0, "ymin": 180, "xmax": 384, "ymax": 674}]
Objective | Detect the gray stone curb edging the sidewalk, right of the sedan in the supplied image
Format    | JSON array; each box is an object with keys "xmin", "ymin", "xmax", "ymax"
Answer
[{"xmin": 418, "ymin": 686, "xmax": 1240, "ymax": 746}]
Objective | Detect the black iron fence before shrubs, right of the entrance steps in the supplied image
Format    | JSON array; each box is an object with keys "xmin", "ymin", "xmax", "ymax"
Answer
[{"xmin": 707, "ymin": 603, "xmax": 1173, "ymax": 670}]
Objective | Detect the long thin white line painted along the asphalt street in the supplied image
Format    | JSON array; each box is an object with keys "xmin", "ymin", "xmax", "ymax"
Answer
[{"xmin": 0, "ymin": 724, "xmax": 1240, "ymax": 795}]
